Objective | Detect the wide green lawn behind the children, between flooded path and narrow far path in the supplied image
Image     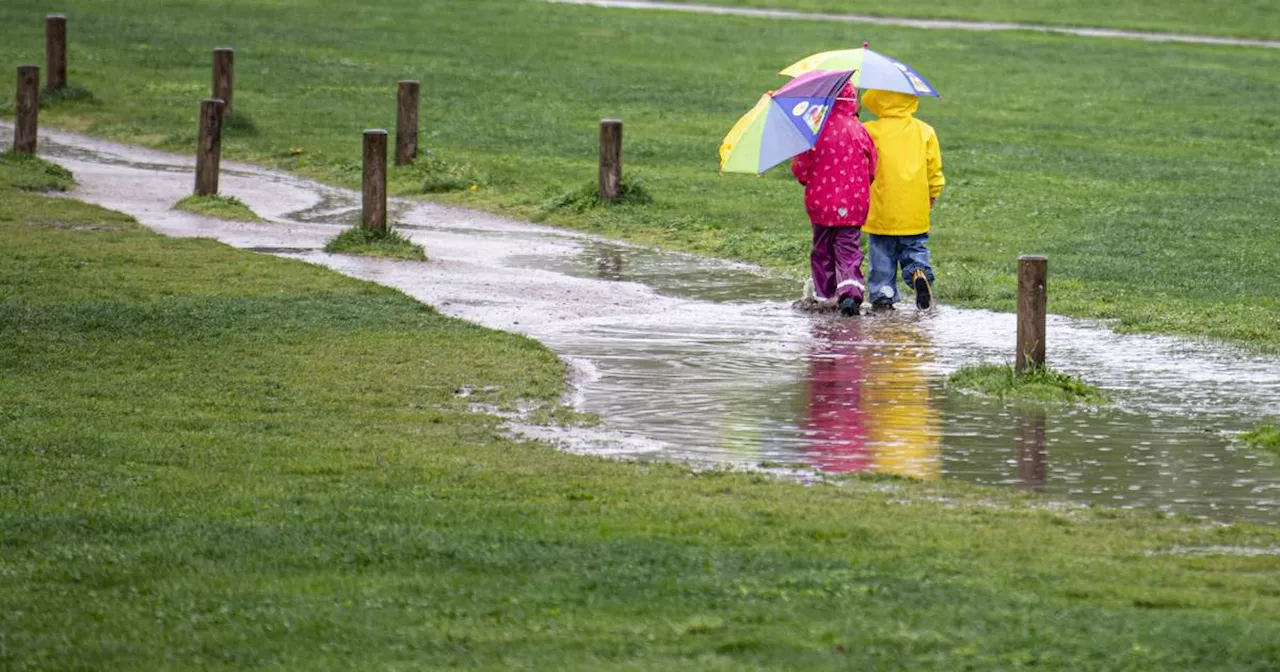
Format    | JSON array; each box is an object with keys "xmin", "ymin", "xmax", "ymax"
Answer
[{"xmin": 0, "ymin": 0, "xmax": 1280, "ymax": 351}]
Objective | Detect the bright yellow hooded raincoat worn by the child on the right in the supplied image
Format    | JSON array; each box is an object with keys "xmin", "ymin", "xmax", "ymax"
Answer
[{"xmin": 863, "ymin": 90, "xmax": 946, "ymax": 236}]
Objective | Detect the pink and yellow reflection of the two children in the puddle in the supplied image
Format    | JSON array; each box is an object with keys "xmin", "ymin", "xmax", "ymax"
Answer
[{"xmin": 805, "ymin": 320, "xmax": 942, "ymax": 480}]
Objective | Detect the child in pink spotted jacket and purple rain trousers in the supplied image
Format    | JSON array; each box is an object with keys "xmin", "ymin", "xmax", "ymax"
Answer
[{"xmin": 791, "ymin": 84, "xmax": 877, "ymax": 315}]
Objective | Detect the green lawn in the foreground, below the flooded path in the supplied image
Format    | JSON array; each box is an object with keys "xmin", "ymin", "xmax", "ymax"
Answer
[{"xmin": 0, "ymin": 163, "xmax": 1280, "ymax": 672}]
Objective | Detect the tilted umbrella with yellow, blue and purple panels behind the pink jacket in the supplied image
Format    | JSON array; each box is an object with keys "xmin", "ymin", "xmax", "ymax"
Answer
[{"xmin": 721, "ymin": 70, "xmax": 854, "ymax": 174}]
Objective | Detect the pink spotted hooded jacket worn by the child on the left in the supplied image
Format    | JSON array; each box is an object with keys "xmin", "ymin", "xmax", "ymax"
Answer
[{"xmin": 791, "ymin": 84, "xmax": 877, "ymax": 227}]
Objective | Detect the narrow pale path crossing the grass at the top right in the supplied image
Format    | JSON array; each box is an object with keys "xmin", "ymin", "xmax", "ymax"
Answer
[{"xmin": 545, "ymin": 0, "xmax": 1280, "ymax": 49}]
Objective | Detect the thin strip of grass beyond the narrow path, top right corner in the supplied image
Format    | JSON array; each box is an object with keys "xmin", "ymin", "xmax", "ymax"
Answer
[{"xmin": 655, "ymin": 0, "xmax": 1280, "ymax": 38}]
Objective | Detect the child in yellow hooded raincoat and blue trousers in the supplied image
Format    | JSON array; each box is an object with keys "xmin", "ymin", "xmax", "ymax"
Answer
[{"xmin": 863, "ymin": 90, "xmax": 946, "ymax": 310}]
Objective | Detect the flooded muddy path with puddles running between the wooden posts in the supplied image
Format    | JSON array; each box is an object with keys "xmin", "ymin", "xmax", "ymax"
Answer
[{"xmin": 10, "ymin": 125, "xmax": 1280, "ymax": 524}]
